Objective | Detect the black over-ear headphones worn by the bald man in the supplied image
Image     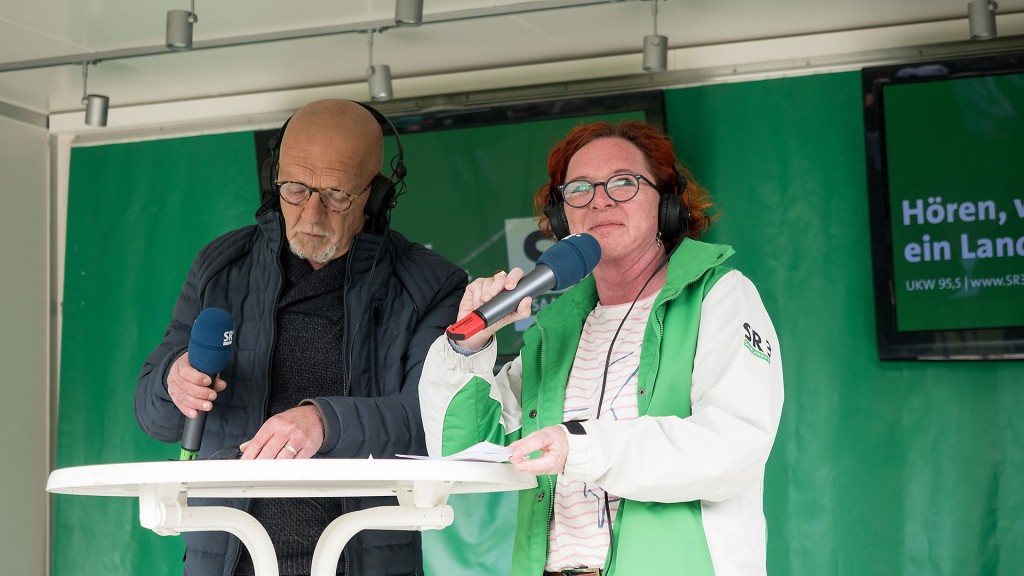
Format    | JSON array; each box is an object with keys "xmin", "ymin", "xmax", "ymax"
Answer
[{"xmin": 259, "ymin": 100, "xmax": 406, "ymax": 236}]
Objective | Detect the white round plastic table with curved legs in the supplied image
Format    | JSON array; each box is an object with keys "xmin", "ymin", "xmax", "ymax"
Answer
[{"xmin": 46, "ymin": 459, "xmax": 537, "ymax": 576}]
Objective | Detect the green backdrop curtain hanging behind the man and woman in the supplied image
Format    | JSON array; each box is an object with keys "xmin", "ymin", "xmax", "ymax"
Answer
[{"xmin": 53, "ymin": 72, "xmax": 1024, "ymax": 576}]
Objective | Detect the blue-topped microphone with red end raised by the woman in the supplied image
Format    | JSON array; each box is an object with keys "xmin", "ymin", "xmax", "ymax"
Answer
[{"xmin": 445, "ymin": 234, "xmax": 601, "ymax": 341}]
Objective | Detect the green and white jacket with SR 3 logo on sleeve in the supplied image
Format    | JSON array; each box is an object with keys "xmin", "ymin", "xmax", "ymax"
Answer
[{"xmin": 419, "ymin": 240, "xmax": 782, "ymax": 576}]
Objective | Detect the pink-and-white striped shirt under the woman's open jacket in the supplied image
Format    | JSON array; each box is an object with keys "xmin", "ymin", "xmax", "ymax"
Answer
[{"xmin": 545, "ymin": 292, "xmax": 657, "ymax": 571}]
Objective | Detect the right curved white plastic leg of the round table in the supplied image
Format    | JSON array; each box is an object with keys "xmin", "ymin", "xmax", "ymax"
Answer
[{"xmin": 311, "ymin": 504, "xmax": 455, "ymax": 576}]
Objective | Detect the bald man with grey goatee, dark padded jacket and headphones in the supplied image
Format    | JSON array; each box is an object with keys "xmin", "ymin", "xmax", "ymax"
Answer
[{"xmin": 135, "ymin": 99, "xmax": 467, "ymax": 576}]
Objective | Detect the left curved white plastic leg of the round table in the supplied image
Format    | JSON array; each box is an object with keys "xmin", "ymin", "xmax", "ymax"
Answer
[{"xmin": 138, "ymin": 484, "xmax": 280, "ymax": 576}]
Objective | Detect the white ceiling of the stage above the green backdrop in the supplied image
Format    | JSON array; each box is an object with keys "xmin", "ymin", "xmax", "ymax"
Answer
[{"xmin": 0, "ymin": 0, "xmax": 1024, "ymax": 130}]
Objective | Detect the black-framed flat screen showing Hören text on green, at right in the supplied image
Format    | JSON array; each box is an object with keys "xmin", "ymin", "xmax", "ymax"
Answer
[{"xmin": 861, "ymin": 52, "xmax": 1024, "ymax": 360}]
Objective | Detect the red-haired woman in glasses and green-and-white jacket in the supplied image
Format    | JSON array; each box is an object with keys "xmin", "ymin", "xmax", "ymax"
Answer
[{"xmin": 420, "ymin": 121, "xmax": 783, "ymax": 576}]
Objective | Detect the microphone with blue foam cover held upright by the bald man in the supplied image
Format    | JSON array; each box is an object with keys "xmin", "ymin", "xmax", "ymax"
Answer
[{"xmin": 178, "ymin": 307, "xmax": 234, "ymax": 460}]
